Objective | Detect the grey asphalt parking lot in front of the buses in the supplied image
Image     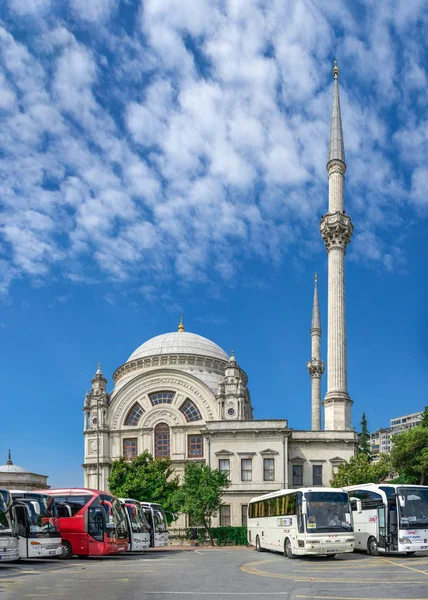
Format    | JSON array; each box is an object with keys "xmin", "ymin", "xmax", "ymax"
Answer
[{"xmin": 0, "ymin": 548, "xmax": 428, "ymax": 600}]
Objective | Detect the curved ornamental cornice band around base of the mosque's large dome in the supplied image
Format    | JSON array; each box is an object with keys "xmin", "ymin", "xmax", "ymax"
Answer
[{"xmin": 113, "ymin": 354, "xmax": 227, "ymax": 384}]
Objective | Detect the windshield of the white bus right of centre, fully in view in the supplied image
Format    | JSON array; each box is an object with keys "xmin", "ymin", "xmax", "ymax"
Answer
[{"xmin": 305, "ymin": 492, "xmax": 353, "ymax": 533}]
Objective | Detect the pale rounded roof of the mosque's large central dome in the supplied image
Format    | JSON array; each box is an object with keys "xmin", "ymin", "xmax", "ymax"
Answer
[{"xmin": 126, "ymin": 331, "xmax": 229, "ymax": 362}]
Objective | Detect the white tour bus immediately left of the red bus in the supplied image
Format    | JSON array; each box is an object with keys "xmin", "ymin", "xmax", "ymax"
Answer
[{"xmin": 10, "ymin": 490, "xmax": 62, "ymax": 558}]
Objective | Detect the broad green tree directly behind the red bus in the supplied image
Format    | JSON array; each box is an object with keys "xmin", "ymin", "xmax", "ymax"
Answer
[{"xmin": 108, "ymin": 450, "xmax": 179, "ymax": 521}]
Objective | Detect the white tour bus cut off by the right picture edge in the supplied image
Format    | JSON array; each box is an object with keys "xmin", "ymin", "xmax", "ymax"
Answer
[{"xmin": 345, "ymin": 483, "xmax": 428, "ymax": 556}]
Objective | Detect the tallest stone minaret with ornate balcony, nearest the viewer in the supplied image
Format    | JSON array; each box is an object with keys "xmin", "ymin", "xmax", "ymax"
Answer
[{"xmin": 320, "ymin": 59, "xmax": 353, "ymax": 431}]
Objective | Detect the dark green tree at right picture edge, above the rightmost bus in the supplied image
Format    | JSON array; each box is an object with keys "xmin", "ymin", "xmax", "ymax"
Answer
[{"xmin": 391, "ymin": 426, "xmax": 428, "ymax": 485}]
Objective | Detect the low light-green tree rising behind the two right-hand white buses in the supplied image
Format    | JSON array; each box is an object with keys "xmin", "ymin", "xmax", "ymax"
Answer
[{"xmin": 330, "ymin": 452, "xmax": 392, "ymax": 487}]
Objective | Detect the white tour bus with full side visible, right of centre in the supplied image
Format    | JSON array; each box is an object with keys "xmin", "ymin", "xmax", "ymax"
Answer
[{"xmin": 247, "ymin": 487, "xmax": 355, "ymax": 558}]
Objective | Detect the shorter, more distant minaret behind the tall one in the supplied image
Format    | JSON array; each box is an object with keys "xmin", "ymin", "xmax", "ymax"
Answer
[{"xmin": 307, "ymin": 273, "xmax": 325, "ymax": 431}]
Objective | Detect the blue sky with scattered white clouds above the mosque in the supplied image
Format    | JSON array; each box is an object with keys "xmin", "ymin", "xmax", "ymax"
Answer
[{"xmin": 0, "ymin": 0, "xmax": 428, "ymax": 485}]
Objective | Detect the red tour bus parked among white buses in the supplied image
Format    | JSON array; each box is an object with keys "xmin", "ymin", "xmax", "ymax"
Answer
[{"xmin": 41, "ymin": 488, "xmax": 128, "ymax": 558}]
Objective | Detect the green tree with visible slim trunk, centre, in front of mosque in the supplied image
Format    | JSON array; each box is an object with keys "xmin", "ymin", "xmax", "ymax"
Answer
[{"xmin": 175, "ymin": 463, "xmax": 230, "ymax": 546}]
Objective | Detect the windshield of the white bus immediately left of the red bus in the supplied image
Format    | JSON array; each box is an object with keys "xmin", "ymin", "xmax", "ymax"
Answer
[{"xmin": 17, "ymin": 493, "xmax": 59, "ymax": 538}]
